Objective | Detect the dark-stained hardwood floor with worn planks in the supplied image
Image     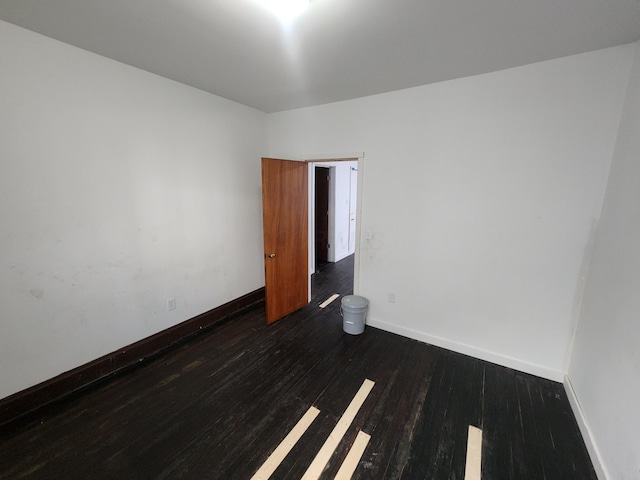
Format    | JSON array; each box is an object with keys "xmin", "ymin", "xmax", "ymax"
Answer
[{"xmin": 0, "ymin": 253, "xmax": 596, "ymax": 480}]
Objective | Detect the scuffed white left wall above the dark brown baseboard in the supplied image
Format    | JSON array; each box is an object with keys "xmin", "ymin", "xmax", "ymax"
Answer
[{"xmin": 0, "ymin": 22, "xmax": 267, "ymax": 397}]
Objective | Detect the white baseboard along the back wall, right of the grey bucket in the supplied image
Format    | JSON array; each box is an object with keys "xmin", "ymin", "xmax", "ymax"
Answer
[{"xmin": 366, "ymin": 317, "xmax": 564, "ymax": 383}]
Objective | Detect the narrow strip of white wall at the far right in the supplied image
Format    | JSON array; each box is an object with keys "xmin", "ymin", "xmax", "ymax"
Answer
[{"xmin": 568, "ymin": 43, "xmax": 640, "ymax": 480}]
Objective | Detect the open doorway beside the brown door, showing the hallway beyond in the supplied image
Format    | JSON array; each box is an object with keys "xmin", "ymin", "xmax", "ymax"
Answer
[{"xmin": 309, "ymin": 158, "xmax": 359, "ymax": 299}]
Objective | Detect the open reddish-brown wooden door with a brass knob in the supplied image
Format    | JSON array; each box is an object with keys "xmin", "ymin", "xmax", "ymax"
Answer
[{"xmin": 262, "ymin": 158, "xmax": 309, "ymax": 323}]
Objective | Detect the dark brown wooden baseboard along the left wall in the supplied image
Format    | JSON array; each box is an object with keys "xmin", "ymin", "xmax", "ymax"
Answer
[{"xmin": 0, "ymin": 287, "xmax": 264, "ymax": 427}]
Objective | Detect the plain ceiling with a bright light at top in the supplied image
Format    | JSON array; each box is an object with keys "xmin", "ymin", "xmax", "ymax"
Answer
[{"xmin": 0, "ymin": 0, "xmax": 640, "ymax": 112}]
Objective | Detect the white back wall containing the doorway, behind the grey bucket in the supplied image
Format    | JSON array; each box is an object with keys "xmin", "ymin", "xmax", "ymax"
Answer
[{"xmin": 268, "ymin": 46, "xmax": 633, "ymax": 380}]
